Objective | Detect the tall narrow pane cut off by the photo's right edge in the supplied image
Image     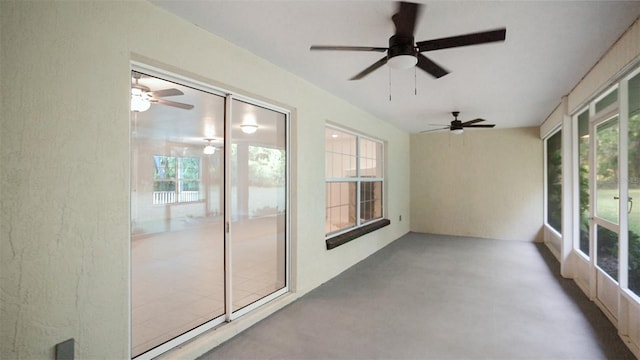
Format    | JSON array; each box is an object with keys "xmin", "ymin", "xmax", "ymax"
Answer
[{"xmin": 627, "ymin": 74, "xmax": 640, "ymax": 296}]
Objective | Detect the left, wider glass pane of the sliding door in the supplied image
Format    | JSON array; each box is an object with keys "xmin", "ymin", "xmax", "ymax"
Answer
[{"xmin": 131, "ymin": 72, "xmax": 225, "ymax": 357}]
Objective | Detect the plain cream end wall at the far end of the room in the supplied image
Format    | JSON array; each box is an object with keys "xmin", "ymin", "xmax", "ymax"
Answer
[{"xmin": 411, "ymin": 128, "xmax": 543, "ymax": 241}]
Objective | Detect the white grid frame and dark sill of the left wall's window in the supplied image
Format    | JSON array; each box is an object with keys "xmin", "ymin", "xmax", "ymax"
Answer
[{"xmin": 325, "ymin": 124, "xmax": 390, "ymax": 245}]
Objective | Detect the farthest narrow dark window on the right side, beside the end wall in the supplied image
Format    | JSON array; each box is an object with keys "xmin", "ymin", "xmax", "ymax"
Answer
[{"xmin": 545, "ymin": 130, "xmax": 562, "ymax": 233}]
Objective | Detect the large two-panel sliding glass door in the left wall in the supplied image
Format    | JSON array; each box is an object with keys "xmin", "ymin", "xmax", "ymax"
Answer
[{"xmin": 131, "ymin": 68, "xmax": 288, "ymax": 359}]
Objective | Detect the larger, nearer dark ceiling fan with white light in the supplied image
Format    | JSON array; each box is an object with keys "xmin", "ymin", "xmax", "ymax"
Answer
[{"xmin": 310, "ymin": 2, "xmax": 507, "ymax": 80}]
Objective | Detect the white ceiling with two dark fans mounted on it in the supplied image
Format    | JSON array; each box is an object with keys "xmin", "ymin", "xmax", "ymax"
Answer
[{"xmin": 152, "ymin": 0, "xmax": 640, "ymax": 133}]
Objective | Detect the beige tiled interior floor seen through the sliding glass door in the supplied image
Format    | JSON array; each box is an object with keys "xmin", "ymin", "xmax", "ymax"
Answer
[{"xmin": 131, "ymin": 217, "xmax": 284, "ymax": 356}]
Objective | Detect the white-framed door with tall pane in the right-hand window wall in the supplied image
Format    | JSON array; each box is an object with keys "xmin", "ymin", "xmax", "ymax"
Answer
[{"xmin": 591, "ymin": 115, "xmax": 619, "ymax": 316}]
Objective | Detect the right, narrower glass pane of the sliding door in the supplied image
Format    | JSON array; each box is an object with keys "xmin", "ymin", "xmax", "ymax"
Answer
[{"xmin": 229, "ymin": 99, "xmax": 287, "ymax": 312}]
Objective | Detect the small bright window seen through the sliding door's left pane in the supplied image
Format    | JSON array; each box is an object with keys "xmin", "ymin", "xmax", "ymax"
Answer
[{"xmin": 153, "ymin": 155, "xmax": 200, "ymax": 205}]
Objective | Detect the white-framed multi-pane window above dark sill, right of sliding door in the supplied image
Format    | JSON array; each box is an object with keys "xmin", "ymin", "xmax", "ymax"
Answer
[{"xmin": 325, "ymin": 127, "xmax": 384, "ymax": 236}]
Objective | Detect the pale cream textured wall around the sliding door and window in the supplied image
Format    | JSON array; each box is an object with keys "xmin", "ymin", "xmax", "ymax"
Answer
[{"xmin": 0, "ymin": 1, "xmax": 409, "ymax": 359}]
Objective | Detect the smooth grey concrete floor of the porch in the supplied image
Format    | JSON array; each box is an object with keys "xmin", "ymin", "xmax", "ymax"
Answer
[{"xmin": 196, "ymin": 233, "xmax": 634, "ymax": 360}]
